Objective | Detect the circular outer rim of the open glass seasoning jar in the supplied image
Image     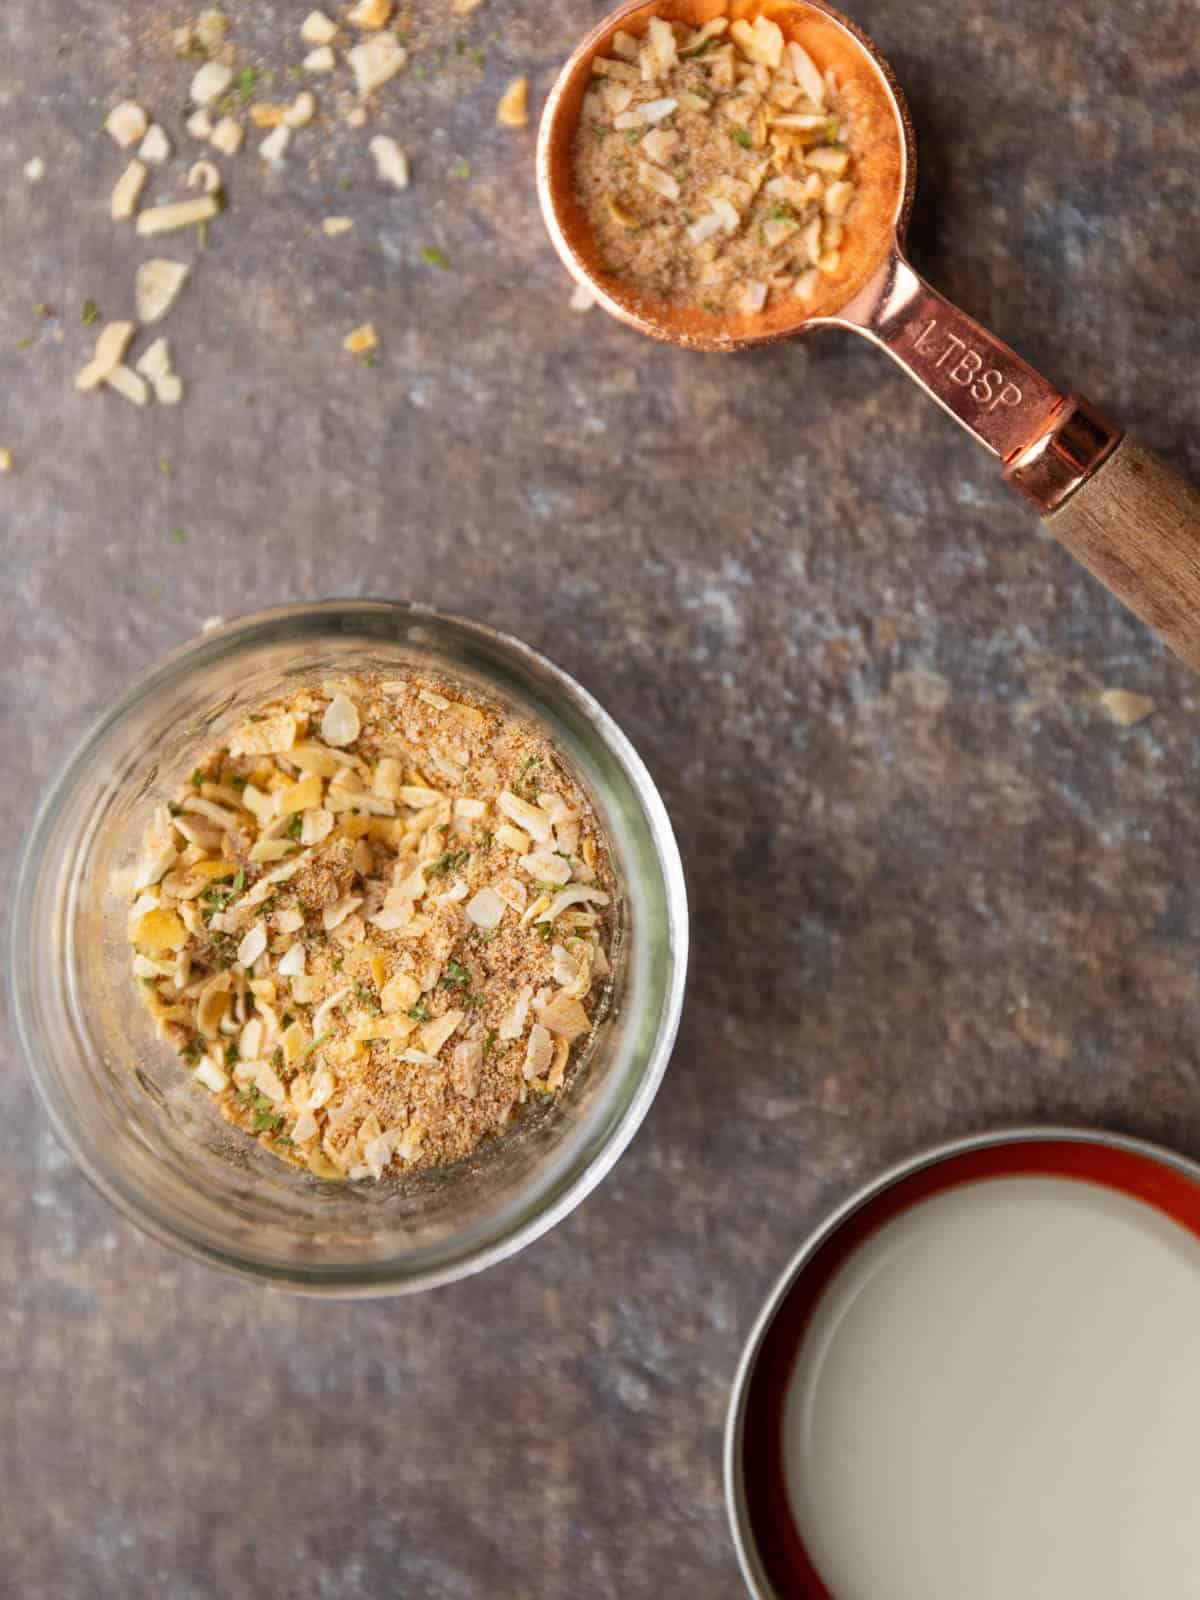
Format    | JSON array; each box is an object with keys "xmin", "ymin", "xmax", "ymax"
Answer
[{"xmin": 5, "ymin": 597, "xmax": 690, "ymax": 1299}]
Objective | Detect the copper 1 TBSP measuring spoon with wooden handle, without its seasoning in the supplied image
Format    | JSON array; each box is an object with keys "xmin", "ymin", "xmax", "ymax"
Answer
[{"xmin": 538, "ymin": 0, "xmax": 1200, "ymax": 669}]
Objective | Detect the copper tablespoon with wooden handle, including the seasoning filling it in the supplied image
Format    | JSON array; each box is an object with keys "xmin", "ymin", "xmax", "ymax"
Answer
[{"xmin": 538, "ymin": 0, "xmax": 1200, "ymax": 669}]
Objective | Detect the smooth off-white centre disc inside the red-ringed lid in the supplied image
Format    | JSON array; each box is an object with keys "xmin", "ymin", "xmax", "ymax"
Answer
[{"xmin": 784, "ymin": 1178, "xmax": 1200, "ymax": 1600}]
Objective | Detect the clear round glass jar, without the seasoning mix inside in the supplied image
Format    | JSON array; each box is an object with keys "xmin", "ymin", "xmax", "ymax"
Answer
[{"xmin": 11, "ymin": 600, "xmax": 688, "ymax": 1296}]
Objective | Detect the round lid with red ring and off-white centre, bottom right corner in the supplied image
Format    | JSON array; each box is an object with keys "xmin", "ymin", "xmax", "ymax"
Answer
[{"xmin": 725, "ymin": 1128, "xmax": 1200, "ymax": 1600}]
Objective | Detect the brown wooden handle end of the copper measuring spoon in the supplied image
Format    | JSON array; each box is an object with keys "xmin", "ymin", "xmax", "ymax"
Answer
[{"xmin": 1045, "ymin": 435, "xmax": 1200, "ymax": 670}]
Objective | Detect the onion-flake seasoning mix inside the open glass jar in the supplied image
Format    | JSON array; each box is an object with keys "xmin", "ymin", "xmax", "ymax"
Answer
[{"xmin": 128, "ymin": 674, "xmax": 613, "ymax": 1179}]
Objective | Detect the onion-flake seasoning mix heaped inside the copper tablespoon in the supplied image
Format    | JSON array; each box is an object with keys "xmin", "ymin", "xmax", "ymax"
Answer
[{"xmin": 574, "ymin": 16, "xmax": 854, "ymax": 315}]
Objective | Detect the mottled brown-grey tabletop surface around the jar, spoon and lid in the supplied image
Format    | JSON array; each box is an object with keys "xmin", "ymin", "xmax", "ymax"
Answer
[{"xmin": 0, "ymin": 0, "xmax": 1200, "ymax": 1600}]
